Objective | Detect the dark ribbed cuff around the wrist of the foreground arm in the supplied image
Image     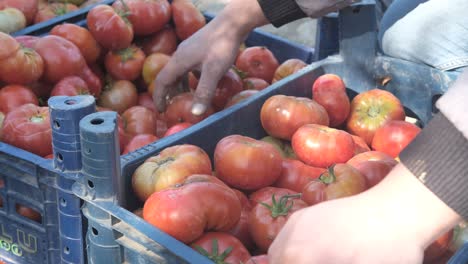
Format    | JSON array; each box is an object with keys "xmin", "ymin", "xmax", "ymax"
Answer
[{"xmin": 400, "ymin": 112, "xmax": 468, "ymax": 219}]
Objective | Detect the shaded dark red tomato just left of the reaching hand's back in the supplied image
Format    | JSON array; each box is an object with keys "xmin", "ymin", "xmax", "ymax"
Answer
[{"xmin": 141, "ymin": 25, "xmax": 177, "ymax": 56}]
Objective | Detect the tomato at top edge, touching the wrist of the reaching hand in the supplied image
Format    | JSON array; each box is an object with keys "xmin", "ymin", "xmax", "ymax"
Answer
[{"xmin": 172, "ymin": 0, "xmax": 206, "ymax": 40}]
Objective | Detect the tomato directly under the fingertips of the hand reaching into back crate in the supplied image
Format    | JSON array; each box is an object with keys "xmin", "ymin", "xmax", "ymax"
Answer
[{"xmin": 165, "ymin": 92, "xmax": 214, "ymax": 127}]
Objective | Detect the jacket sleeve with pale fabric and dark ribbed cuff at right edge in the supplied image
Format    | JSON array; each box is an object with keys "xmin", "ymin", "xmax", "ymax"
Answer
[{"xmin": 400, "ymin": 71, "xmax": 468, "ymax": 219}]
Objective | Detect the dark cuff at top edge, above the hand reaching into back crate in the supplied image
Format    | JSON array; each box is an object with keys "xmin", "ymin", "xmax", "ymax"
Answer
[{"xmin": 258, "ymin": 0, "xmax": 307, "ymax": 27}]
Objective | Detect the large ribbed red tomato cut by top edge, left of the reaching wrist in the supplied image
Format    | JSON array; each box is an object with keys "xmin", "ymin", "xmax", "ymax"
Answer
[{"xmin": 112, "ymin": 0, "xmax": 171, "ymax": 36}]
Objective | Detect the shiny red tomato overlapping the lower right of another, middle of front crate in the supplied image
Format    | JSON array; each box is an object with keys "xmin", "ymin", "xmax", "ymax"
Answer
[{"xmin": 291, "ymin": 124, "xmax": 354, "ymax": 168}]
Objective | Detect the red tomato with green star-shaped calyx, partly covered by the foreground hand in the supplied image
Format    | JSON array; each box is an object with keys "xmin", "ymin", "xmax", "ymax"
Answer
[{"xmin": 249, "ymin": 194, "xmax": 308, "ymax": 253}]
